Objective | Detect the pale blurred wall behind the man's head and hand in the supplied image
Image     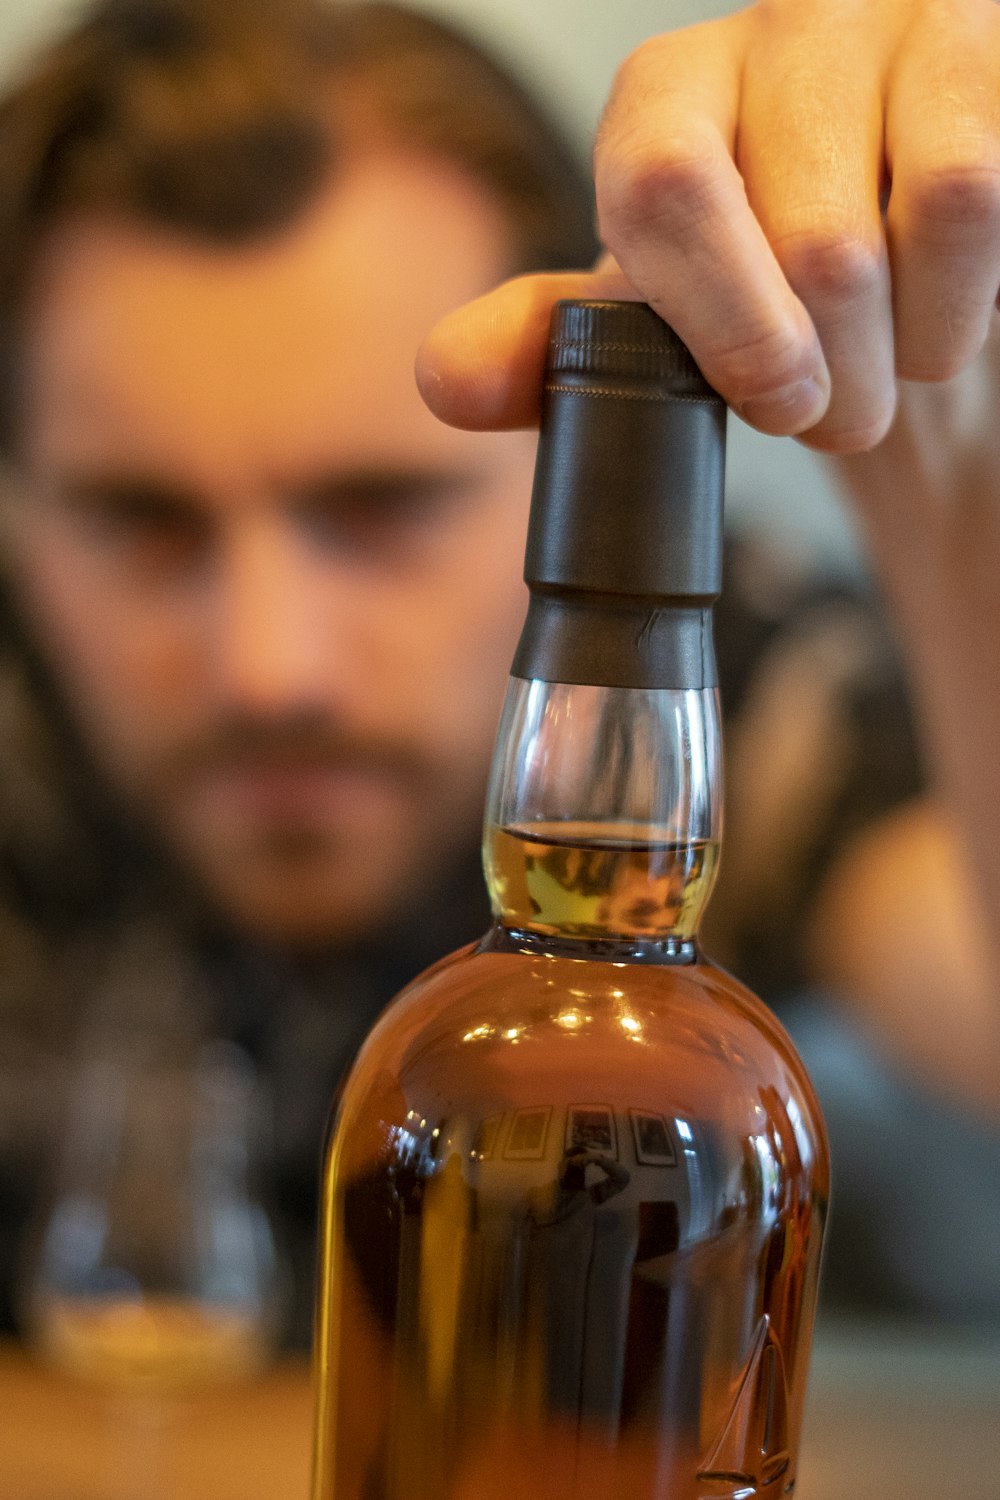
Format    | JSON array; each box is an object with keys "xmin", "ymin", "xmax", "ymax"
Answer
[{"xmin": 0, "ymin": 0, "xmax": 856, "ymax": 569}]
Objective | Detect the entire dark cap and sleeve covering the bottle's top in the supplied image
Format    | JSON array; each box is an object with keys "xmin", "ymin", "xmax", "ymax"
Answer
[{"xmin": 514, "ymin": 302, "xmax": 726, "ymax": 687}]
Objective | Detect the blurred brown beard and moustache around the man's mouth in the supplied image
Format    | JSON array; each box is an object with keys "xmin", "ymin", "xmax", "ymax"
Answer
[{"xmin": 122, "ymin": 713, "xmax": 481, "ymax": 947}]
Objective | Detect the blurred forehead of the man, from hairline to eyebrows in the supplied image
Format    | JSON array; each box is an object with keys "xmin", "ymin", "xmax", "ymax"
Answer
[{"xmin": 21, "ymin": 158, "xmax": 515, "ymax": 483}]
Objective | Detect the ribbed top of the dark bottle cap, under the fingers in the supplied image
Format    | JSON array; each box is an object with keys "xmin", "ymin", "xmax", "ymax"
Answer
[{"xmin": 546, "ymin": 302, "xmax": 721, "ymax": 401}]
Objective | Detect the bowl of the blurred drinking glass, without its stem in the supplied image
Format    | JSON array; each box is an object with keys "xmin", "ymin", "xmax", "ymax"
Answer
[{"xmin": 27, "ymin": 1037, "xmax": 280, "ymax": 1392}]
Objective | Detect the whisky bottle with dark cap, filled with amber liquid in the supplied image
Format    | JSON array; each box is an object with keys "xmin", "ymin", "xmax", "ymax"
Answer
[{"xmin": 313, "ymin": 303, "xmax": 828, "ymax": 1500}]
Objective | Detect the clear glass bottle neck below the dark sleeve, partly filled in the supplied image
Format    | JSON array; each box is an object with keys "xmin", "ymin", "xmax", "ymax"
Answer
[{"xmin": 484, "ymin": 677, "xmax": 721, "ymax": 957}]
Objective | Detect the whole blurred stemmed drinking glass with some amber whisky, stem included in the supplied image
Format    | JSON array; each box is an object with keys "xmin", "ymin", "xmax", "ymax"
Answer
[{"xmin": 16, "ymin": 927, "xmax": 288, "ymax": 1500}]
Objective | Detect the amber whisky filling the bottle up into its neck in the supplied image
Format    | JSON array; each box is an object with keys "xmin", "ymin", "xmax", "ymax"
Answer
[{"xmin": 313, "ymin": 827, "xmax": 828, "ymax": 1500}]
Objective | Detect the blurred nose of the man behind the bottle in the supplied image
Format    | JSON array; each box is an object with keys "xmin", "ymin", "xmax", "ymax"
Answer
[{"xmin": 211, "ymin": 519, "xmax": 336, "ymax": 716}]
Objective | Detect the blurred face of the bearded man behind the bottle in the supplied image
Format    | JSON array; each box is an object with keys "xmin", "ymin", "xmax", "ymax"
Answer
[{"xmin": 10, "ymin": 156, "xmax": 534, "ymax": 942}]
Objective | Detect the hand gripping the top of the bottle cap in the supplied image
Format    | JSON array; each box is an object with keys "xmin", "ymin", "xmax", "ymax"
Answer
[{"xmin": 418, "ymin": 0, "xmax": 1000, "ymax": 453}]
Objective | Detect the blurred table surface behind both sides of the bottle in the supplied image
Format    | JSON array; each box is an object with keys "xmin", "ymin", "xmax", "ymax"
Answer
[{"xmin": 0, "ymin": 1325, "xmax": 1000, "ymax": 1500}]
